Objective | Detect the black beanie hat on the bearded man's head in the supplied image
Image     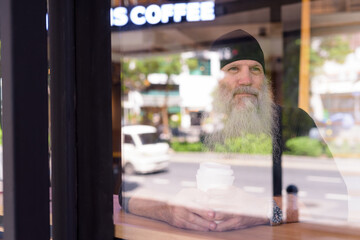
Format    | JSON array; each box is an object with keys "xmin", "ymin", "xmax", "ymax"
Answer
[{"xmin": 211, "ymin": 29, "xmax": 265, "ymax": 73}]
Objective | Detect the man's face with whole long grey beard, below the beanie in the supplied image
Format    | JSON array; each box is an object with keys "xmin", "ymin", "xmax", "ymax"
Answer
[{"xmin": 206, "ymin": 60, "xmax": 274, "ymax": 146}]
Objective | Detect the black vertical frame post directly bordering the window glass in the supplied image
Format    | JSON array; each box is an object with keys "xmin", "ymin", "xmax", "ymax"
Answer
[{"xmin": 75, "ymin": 0, "xmax": 114, "ymax": 240}]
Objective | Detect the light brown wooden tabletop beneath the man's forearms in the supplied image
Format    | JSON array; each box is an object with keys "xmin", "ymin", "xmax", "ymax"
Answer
[{"xmin": 114, "ymin": 196, "xmax": 360, "ymax": 240}]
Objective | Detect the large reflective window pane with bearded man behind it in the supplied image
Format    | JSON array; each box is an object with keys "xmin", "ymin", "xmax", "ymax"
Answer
[{"xmin": 112, "ymin": 0, "xmax": 360, "ymax": 239}]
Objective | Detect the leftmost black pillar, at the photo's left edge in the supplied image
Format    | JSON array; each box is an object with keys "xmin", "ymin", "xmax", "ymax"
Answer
[{"xmin": 0, "ymin": 0, "xmax": 50, "ymax": 240}]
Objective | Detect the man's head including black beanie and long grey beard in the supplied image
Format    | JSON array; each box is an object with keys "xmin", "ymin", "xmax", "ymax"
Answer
[{"xmin": 212, "ymin": 30, "xmax": 274, "ymax": 140}]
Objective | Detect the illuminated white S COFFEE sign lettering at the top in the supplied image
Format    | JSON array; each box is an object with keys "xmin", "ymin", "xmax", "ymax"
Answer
[{"xmin": 110, "ymin": 1, "xmax": 215, "ymax": 27}]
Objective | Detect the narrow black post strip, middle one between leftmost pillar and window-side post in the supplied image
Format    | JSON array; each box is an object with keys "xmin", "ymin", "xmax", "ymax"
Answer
[{"xmin": 49, "ymin": 0, "xmax": 78, "ymax": 240}]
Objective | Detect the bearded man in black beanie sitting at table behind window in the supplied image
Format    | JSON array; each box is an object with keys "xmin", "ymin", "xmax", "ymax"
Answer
[{"xmin": 122, "ymin": 30, "xmax": 348, "ymax": 231}]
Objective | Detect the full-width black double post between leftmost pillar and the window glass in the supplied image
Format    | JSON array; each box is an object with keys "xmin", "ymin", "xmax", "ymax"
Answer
[{"xmin": 49, "ymin": 0, "xmax": 114, "ymax": 240}]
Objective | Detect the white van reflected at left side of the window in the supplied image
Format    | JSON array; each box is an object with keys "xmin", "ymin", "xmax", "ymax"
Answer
[{"xmin": 122, "ymin": 125, "xmax": 170, "ymax": 174}]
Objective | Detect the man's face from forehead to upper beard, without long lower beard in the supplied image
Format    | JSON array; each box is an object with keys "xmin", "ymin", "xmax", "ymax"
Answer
[{"xmin": 219, "ymin": 60, "xmax": 265, "ymax": 109}]
